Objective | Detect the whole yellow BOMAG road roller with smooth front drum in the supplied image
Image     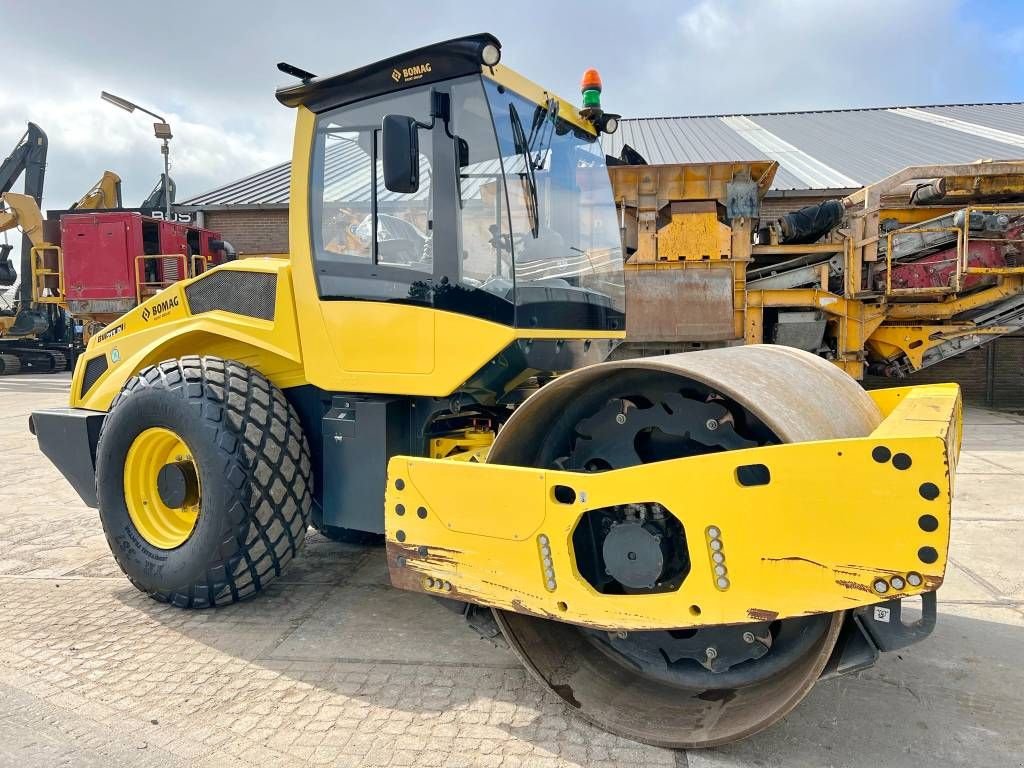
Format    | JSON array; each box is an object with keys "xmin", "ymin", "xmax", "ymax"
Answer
[{"xmin": 31, "ymin": 35, "xmax": 959, "ymax": 746}]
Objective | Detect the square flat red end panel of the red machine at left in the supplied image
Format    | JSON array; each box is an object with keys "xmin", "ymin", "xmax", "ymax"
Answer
[{"xmin": 60, "ymin": 217, "xmax": 143, "ymax": 301}]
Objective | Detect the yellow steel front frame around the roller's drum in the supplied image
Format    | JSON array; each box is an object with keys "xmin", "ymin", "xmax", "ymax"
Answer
[{"xmin": 385, "ymin": 384, "xmax": 962, "ymax": 630}]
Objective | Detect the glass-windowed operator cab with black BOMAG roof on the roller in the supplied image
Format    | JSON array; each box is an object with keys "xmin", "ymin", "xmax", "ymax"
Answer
[{"xmin": 278, "ymin": 35, "xmax": 625, "ymax": 331}]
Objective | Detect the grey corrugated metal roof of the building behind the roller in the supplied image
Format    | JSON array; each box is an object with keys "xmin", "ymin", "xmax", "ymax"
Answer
[{"xmin": 182, "ymin": 102, "xmax": 1024, "ymax": 208}]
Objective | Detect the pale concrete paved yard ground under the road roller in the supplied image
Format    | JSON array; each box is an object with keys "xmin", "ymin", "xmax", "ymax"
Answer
[{"xmin": 0, "ymin": 376, "xmax": 1024, "ymax": 768}]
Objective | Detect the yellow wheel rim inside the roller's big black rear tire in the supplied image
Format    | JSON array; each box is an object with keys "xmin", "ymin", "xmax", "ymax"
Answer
[{"xmin": 125, "ymin": 427, "xmax": 202, "ymax": 549}]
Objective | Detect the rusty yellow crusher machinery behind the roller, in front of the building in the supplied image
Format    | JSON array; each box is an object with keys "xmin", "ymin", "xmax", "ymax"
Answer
[{"xmin": 608, "ymin": 156, "xmax": 1024, "ymax": 379}]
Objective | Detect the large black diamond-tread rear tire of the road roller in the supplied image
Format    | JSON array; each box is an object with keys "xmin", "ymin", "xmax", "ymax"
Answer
[{"xmin": 96, "ymin": 356, "xmax": 312, "ymax": 608}]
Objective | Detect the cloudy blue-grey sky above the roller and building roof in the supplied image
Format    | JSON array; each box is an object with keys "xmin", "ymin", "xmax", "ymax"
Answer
[{"xmin": 0, "ymin": 0, "xmax": 1024, "ymax": 209}]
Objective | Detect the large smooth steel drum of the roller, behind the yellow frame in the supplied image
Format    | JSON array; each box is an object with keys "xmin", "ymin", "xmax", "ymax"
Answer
[{"xmin": 488, "ymin": 346, "xmax": 881, "ymax": 748}]
